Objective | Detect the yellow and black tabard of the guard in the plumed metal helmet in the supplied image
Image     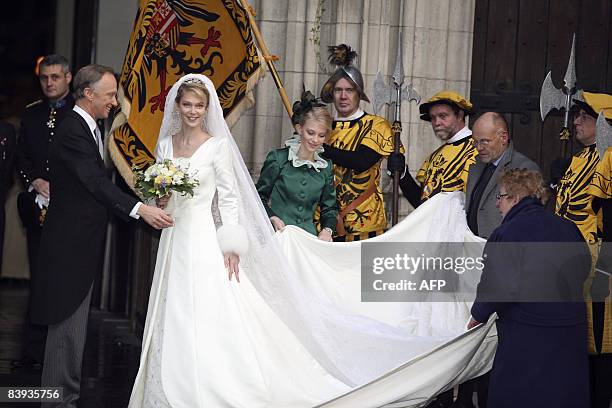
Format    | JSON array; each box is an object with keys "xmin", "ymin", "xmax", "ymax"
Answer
[{"xmin": 329, "ymin": 113, "xmax": 396, "ymax": 241}]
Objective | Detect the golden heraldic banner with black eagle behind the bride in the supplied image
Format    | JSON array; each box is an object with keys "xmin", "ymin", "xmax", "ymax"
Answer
[{"xmin": 109, "ymin": 0, "xmax": 263, "ymax": 186}]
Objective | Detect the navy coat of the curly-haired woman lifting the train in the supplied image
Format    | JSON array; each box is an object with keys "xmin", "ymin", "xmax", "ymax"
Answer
[{"xmin": 472, "ymin": 197, "xmax": 590, "ymax": 408}]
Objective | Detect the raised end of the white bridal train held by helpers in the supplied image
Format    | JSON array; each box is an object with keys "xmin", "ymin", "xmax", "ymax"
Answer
[{"xmin": 277, "ymin": 193, "xmax": 497, "ymax": 408}]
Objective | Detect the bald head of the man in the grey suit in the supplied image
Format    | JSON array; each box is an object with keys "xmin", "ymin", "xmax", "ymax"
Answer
[{"xmin": 472, "ymin": 112, "xmax": 510, "ymax": 163}]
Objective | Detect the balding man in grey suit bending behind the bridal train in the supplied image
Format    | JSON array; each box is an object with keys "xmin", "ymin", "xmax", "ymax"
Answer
[{"xmin": 465, "ymin": 112, "xmax": 540, "ymax": 238}]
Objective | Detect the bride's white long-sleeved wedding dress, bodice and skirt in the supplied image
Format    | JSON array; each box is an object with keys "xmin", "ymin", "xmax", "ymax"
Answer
[{"xmin": 129, "ymin": 137, "xmax": 358, "ymax": 408}]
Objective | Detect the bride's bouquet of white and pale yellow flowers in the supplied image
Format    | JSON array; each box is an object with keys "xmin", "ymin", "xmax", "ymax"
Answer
[{"xmin": 132, "ymin": 159, "xmax": 200, "ymax": 200}]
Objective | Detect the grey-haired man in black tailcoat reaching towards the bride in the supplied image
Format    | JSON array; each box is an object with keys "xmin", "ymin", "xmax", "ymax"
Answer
[{"xmin": 31, "ymin": 65, "xmax": 172, "ymax": 407}]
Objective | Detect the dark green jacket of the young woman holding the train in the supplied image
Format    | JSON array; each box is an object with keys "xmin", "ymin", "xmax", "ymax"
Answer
[{"xmin": 256, "ymin": 147, "xmax": 338, "ymax": 235}]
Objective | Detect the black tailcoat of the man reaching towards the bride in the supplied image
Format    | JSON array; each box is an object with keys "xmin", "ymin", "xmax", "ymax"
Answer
[{"xmin": 30, "ymin": 111, "xmax": 138, "ymax": 324}]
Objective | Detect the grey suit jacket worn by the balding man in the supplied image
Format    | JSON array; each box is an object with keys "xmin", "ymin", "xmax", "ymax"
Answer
[{"xmin": 465, "ymin": 141, "xmax": 540, "ymax": 238}]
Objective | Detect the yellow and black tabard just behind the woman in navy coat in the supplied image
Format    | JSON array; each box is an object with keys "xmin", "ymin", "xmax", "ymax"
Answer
[{"xmin": 555, "ymin": 144, "xmax": 601, "ymax": 244}]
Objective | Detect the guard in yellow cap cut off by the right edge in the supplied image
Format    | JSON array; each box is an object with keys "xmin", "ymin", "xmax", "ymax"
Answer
[{"xmin": 581, "ymin": 92, "xmax": 612, "ymax": 408}]
